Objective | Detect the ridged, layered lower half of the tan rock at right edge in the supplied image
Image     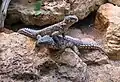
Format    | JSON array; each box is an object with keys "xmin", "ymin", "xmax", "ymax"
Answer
[{"xmin": 105, "ymin": 20, "xmax": 120, "ymax": 60}]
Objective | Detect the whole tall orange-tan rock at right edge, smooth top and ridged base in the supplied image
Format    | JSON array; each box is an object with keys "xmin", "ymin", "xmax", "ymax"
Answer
[{"xmin": 95, "ymin": 3, "xmax": 120, "ymax": 59}]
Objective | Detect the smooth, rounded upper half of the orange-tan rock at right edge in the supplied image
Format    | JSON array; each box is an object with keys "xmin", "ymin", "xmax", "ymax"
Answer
[{"xmin": 95, "ymin": 3, "xmax": 120, "ymax": 32}]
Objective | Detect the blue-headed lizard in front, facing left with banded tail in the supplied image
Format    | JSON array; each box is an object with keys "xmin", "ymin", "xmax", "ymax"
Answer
[{"xmin": 36, "ymin": 35, "xmax": 107, "ymax": 54}]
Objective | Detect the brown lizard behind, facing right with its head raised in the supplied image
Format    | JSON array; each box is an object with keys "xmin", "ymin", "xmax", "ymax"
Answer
[{"xmin": 18, "ymin": 15, "xmax": 78, "ymax": 39}]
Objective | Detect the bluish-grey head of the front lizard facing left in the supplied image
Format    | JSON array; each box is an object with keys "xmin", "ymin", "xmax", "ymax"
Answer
[{"xmin": 36, "ymin": 35, "xmax": 55, "ymax": 48}]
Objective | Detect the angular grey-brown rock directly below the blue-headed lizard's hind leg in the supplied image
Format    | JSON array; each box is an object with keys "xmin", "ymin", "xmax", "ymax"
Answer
[{"xmin": 48, "ymin": 48, "xmax": 89, "ymax": 82}]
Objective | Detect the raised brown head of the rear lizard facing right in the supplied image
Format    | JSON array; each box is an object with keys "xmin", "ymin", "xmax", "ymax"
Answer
[{"xmin": 64, "ymin": 15, "xmax": 78, "ymax": 24}]
